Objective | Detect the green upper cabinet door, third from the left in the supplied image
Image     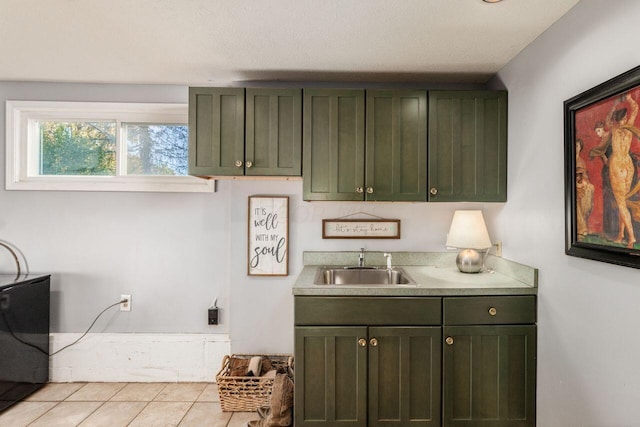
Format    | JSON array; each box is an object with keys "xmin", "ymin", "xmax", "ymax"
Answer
[{"xmin": 302, "ymin": 89, "xmax": 365, "ymax": 200}]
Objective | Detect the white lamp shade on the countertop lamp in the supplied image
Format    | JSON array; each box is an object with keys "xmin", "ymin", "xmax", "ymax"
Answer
[{"xmin": 446, "ymin": 211, "xmax": 491, "ymax": 249}]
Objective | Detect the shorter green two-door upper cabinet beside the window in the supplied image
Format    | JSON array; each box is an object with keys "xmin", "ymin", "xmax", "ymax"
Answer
[{"xmin": 189, "ymin": 87, "xmax": 302, "ymax": 176}]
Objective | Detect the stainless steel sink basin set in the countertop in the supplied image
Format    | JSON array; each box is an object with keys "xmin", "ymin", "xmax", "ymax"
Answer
[{"xmin": 315, "ymin": 267, "xmax": 415, "ymax": 286}]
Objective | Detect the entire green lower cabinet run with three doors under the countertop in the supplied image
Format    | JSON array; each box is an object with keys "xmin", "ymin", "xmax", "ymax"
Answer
[{"xmin": 294, "ymin": 295, "xmax": 537, "ymax": 427}]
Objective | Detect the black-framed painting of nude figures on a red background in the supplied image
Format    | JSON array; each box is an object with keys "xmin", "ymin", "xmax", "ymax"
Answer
[{"xmin": 564, "ymin": 66, "xmax": 640, "ymax": 268}]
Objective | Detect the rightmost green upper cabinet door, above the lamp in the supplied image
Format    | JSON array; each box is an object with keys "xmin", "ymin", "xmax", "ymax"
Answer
[{"xmin": 429, "ymin": 91, "xmax": 507, "ymax": 202}]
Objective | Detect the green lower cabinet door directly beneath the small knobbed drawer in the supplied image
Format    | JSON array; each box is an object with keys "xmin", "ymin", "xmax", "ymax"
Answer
[{"xmin": 443, "ymin": 325, "xmax": 536, "ymax": 427}]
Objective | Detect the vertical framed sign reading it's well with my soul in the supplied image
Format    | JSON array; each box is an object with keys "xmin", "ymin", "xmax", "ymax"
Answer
[{"xmin": 248, "ymin": 196, "xmax": 289, "ymax": 276}]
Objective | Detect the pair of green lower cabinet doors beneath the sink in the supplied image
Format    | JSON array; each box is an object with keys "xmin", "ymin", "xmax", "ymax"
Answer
[{"xmin": 295, "ymin": 326, "xmax": 441, "ymax": 427}]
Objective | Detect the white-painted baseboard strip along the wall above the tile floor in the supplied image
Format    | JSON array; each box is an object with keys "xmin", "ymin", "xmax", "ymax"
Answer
[{"xmin": 49, "ymin": 333, "xmax": 231, "ymax": 382}]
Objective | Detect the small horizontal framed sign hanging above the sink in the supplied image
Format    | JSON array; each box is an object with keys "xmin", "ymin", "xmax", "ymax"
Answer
[{"xmin": 322, "ymin": 219, "xmax": 400, "ymax": 239}]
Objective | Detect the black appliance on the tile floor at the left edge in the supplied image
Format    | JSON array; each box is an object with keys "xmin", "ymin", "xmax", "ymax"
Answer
[{"xmin": 0, "ymin": 274, "xmax": 50, "ymax": 411}]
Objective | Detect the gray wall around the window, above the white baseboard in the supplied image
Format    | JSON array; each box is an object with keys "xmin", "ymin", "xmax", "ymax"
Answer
[{"xmin": 0, "ymin": 83, "xmax": 229, "ymax": 333}]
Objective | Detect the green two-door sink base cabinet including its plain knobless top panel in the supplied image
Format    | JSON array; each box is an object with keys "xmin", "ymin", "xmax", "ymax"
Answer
[{"xmin": 294, "ymin": 296, "xmax": 442, "ymax": 427}]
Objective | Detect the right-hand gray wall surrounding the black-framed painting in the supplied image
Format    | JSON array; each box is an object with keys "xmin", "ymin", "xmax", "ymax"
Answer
[{"xmin": 493, "ymin": 0, "xmax": 640, "ymax": 427}]
